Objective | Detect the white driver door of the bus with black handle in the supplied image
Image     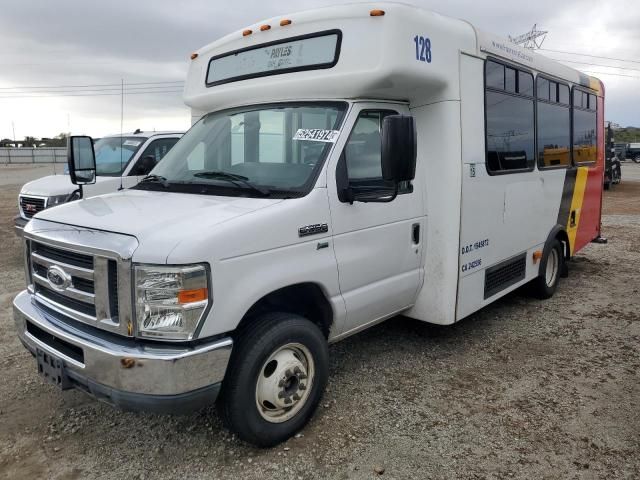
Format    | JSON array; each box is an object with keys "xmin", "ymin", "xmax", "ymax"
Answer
[{"xmin": 327, "ymin": 103, "xmax": 425, "ymax": 332}]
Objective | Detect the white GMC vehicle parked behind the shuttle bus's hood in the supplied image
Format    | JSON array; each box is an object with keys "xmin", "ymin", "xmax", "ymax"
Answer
[{"xmin": 14, "ymin": 130, "xmax": 183, "ymax": 235}]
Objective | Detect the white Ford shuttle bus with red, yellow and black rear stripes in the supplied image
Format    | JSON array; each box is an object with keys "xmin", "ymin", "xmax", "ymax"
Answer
[{"xmin": 14, "ymin": 3, "xmax": 604, "ymax": 446}]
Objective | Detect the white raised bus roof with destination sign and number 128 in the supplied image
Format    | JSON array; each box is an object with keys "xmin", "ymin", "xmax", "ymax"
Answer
[{"xmin": 184, "ymin": 2, "xmax": 602, "ymax": 112}]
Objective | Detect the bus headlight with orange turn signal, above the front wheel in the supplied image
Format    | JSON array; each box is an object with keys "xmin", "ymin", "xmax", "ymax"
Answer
[{"xmin": 134, "ymin": 265, "xmax": 210, "ymax": 340}]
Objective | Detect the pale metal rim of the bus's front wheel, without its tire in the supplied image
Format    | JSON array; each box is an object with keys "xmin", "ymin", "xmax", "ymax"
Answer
[{"xmin": 256, "ymin": 343, "xmax": 315, "ymax": 423}]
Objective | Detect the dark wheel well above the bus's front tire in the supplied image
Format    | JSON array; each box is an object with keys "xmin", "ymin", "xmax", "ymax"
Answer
[{"xmin": 238, "ymin": 283, "xmax": 333, "ymax": 338}]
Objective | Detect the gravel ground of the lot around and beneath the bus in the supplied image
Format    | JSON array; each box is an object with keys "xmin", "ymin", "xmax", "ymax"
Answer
[{"xmin": 0, "ymin": 165, "xmax": 640, "ymax": 480}]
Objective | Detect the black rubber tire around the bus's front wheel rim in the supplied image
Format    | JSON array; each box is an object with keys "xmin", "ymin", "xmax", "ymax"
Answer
[{"xmin": 218, "ymin": 313, "xmax": 329, "ymax": 447}]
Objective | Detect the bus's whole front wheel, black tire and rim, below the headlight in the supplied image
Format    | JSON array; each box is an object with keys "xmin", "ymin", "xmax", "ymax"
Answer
[{"xmin": 218, "ymin": 313, "xmax": 329, "ymax": 447}]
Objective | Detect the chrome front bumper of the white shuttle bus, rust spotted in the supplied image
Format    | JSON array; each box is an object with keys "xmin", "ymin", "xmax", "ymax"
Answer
[{"xmin": 13, "ymin": 290, "xmax": 233, "ymax": 413}]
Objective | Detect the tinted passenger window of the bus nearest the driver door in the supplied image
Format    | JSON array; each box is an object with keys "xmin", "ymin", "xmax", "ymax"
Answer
[{"xmin": 485, "ymin": 61, "xmax": 535, "ymax": 173}]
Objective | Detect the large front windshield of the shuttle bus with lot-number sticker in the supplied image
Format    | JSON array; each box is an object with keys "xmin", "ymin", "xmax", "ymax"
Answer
[{"xmin": 144, "ymin": 102, "xmax": 347, "ymax": 198}]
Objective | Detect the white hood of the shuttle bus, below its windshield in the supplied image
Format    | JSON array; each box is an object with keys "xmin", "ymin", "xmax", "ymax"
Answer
[{"xmin": 34, "ymin": 190, "xmax": 282, "ymax": 263}]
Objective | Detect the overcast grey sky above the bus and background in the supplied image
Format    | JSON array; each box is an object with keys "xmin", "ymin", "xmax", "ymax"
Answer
[{"xmin": 0, "ymin": 0, "xmax": 640, "ymax": 139}]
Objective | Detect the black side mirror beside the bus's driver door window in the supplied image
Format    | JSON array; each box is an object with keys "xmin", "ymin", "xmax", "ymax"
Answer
[{"xmin": 382, "ymin": 115, "xmax": 417, "ymax": 184}]
